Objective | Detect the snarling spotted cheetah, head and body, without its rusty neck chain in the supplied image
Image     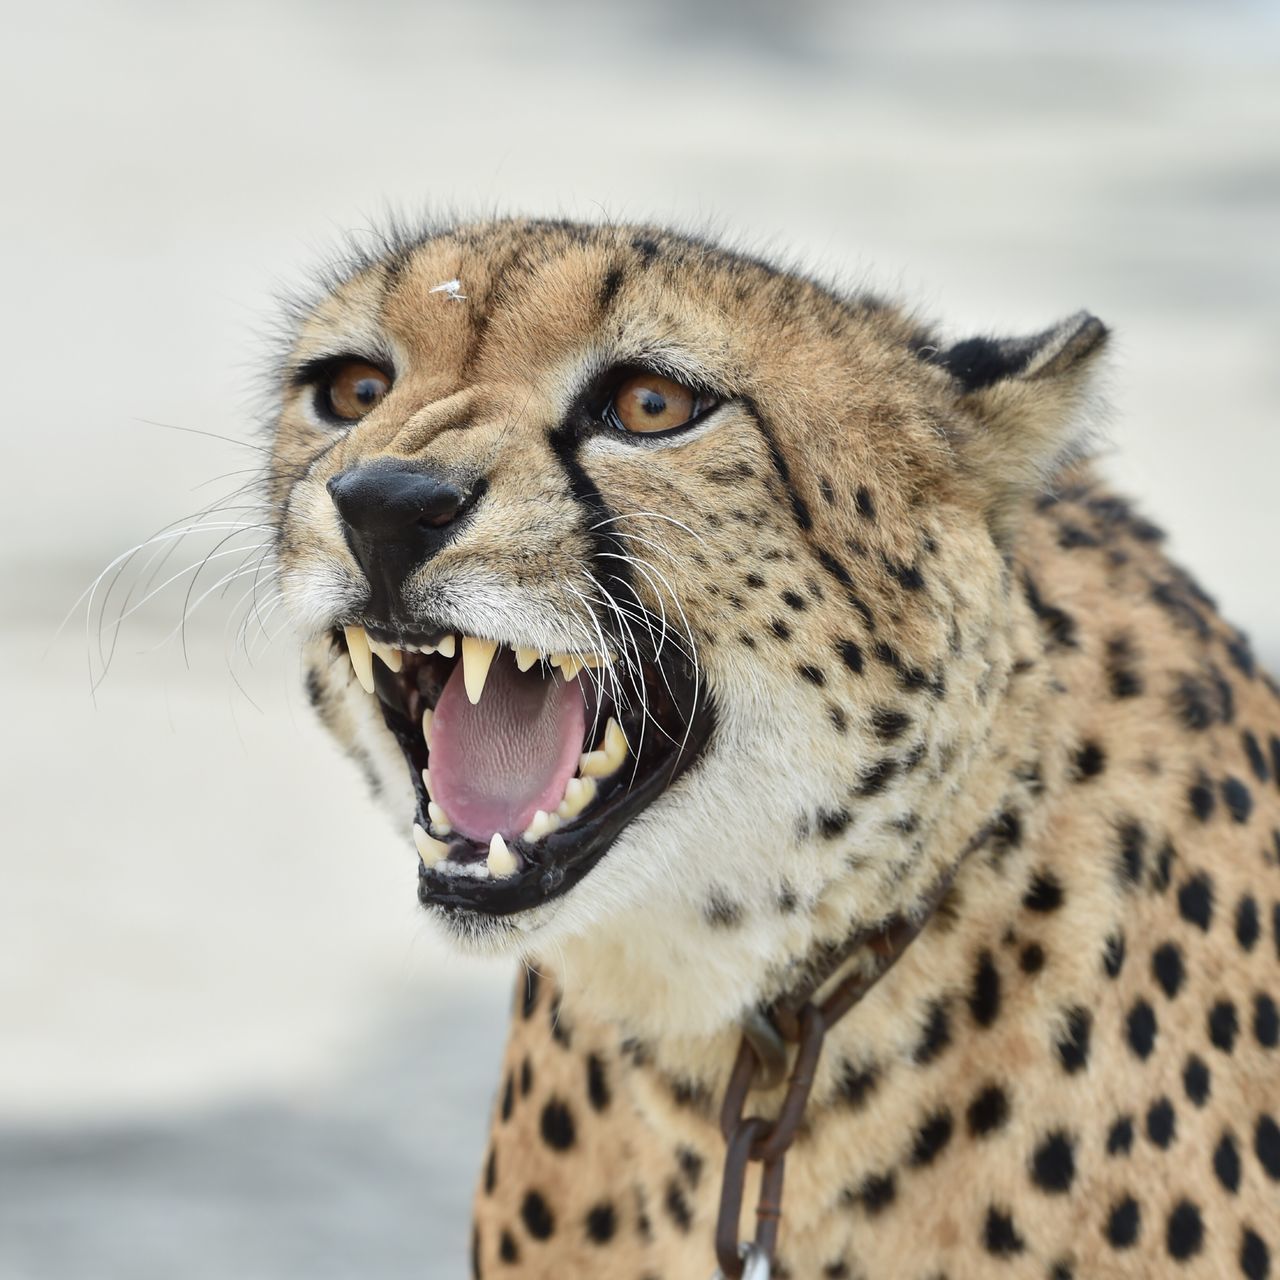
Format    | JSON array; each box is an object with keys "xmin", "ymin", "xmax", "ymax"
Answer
[{"xmin": 268, "ymin": 220, "xmax": 1280, "ymax": 1280}]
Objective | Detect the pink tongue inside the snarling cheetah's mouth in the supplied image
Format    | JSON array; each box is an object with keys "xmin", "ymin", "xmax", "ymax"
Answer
[{"xmin": 429, "ymin": 649, "xmax": 586, "ymax": 845}]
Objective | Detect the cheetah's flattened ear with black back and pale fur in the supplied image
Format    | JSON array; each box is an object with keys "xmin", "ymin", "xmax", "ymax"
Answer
[{"xmin": 932, "ymin": 311, "xmax": 1108, "ymax": 540}]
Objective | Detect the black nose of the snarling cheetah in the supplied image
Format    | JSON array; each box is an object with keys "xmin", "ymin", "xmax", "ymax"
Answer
[{"xmin": 329, "ymin": 461, "xmax": 480, "ymax": 622}]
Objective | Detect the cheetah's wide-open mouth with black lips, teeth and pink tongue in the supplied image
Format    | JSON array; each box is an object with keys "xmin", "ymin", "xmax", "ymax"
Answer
[{"xmin": 334, "ymin": 623, "xmax": 714, "ymax": 915}]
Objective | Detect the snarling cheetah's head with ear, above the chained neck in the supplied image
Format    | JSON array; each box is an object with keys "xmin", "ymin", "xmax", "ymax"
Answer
[{"xmin": 270, "ymin": 221, "xmax": 1106, "ymax": 1024}]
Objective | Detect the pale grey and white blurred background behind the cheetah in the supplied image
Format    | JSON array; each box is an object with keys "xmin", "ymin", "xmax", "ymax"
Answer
[{"xmin": 0, "ymin": 0, "xmax": 1280, "ymax": 1280}]
